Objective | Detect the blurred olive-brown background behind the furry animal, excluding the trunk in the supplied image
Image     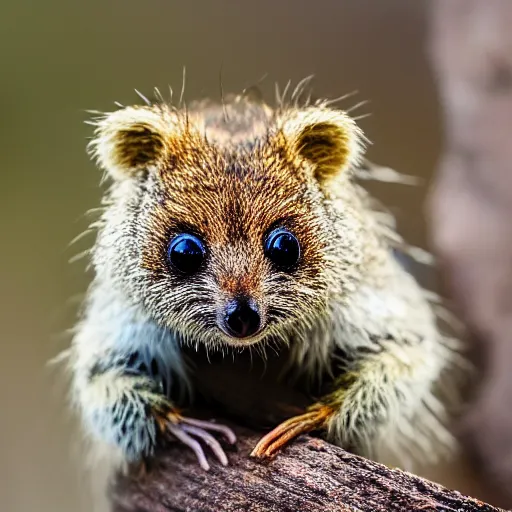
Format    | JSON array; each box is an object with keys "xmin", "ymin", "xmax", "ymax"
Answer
[{"xmin": 0, "ymin": 0, "xmax": 504, "ymax": 512}]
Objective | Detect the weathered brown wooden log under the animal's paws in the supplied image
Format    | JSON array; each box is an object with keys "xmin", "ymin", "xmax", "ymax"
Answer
[{"xmin": 111, "ymin": 427, "xmax": 500, "ymax": 512}]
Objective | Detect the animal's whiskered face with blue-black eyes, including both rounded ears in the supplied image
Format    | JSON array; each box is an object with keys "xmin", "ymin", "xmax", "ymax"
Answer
[{"xmin": 93, "ymin": 97, "xmax": 366, "ymax": 345}]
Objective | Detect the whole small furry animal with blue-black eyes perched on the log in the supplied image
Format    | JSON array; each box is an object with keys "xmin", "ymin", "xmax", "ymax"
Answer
[{"xmin": 71, "ymin": 83, "xmax": 455, "ymax": 469}]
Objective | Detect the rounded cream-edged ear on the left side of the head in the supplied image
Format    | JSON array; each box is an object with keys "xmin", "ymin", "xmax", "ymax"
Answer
[{"xmin": 88, "ymin": 105, "xmax": 178, "ymax": 180}]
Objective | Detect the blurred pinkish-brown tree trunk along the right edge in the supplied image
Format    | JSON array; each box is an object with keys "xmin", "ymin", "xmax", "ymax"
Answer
[{"xmin": 429, "ymin": 0, "xmax": 512, "ymax": 505}]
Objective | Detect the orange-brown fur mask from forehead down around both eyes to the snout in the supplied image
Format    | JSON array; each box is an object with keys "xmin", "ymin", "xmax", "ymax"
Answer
[{"xmin": 136, "ymin": 119, "xmax": 330, "ymax": 293}]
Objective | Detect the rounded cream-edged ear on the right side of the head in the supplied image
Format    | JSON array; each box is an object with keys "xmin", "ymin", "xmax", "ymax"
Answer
[{"xmin": 280, "ymin": 106, "xmax": 365, "ymax": 182}]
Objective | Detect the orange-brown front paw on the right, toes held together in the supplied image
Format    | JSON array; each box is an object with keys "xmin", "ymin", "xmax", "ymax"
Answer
[{"xmin": 251, "ymin": 404, "xmax": 334, "ymax": 459}]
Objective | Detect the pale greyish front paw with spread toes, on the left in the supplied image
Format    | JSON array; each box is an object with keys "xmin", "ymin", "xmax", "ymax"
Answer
[{"xmin": 157, "ymin": 412, "xmax": 236, "ymax": 471}]
